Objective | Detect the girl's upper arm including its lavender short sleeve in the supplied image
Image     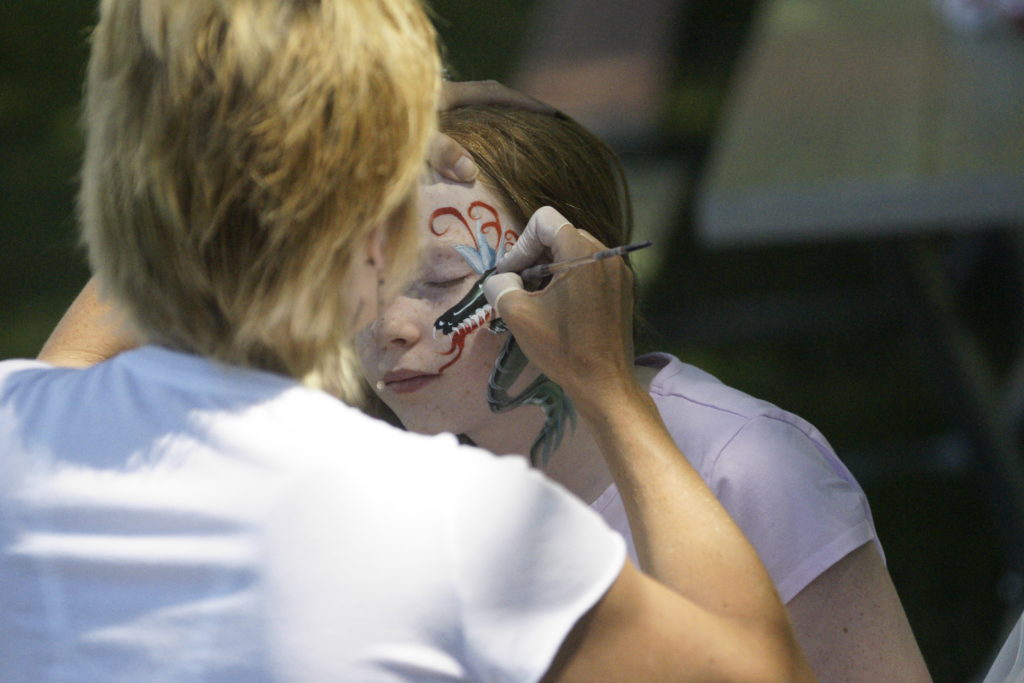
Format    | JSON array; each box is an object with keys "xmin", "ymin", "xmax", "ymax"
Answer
[{"xmin": 708, "ymin": 413, "xmax": 928, "ymax": 681}]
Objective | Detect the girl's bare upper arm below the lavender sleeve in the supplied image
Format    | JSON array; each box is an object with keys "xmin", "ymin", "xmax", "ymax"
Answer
[{"xmin": 786, "ymin": 542, "xmax": 931, "ymax": 683}]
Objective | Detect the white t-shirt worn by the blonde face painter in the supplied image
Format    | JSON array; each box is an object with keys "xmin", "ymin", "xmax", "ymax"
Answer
[{"xmin": 0, "ymin": 347, "xmax": 625, "ymax": 683}]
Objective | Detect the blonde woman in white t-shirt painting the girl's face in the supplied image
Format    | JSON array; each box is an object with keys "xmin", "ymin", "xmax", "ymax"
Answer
[{"xmin": 0, "ymin": 0, "xmax": 808, "ymax": 682}]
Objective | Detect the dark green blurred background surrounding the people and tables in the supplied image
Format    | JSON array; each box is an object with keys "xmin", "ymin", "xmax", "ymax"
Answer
[{"xmin": 0, "ymin": 0, "xmax": 1020, "ymax": 681}]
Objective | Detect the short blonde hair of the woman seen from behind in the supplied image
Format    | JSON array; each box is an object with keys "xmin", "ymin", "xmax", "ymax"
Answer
[{"xmin": 79, "ymin": 0, "xmax": 440, "ymax": 378}]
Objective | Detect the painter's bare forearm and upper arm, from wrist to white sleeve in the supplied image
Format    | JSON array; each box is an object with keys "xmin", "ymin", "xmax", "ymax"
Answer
[{"xmin": 549, "ymin": 386, "xmax": 813, "ymax": 681}]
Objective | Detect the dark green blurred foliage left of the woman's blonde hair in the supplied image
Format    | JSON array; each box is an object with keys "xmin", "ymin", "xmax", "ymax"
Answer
[{"xmin": 0, "ymin": 0, "xmax": 95, "ymax": 357}]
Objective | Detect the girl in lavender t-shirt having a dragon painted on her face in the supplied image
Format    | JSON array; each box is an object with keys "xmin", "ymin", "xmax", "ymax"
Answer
[{"xmin": 358, "ymin": 105, "xmax": 928, "ymax": 681}]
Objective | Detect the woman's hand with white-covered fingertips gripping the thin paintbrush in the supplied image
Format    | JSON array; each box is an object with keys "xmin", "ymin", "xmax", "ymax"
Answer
[{"xmin": 484, "ymin": 207, "xmax": 633, "ymax": 402}]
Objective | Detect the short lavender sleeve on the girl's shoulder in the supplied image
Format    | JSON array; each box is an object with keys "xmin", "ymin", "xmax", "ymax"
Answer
[{"xmin": 710, "ymin": 416, "xmax": 881, "ymax": 602}]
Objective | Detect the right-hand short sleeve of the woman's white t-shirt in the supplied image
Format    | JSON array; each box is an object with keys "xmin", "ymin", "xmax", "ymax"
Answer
[{"xmin": 452, "ymin": 457, "xmax": 626, "ymax": 681}]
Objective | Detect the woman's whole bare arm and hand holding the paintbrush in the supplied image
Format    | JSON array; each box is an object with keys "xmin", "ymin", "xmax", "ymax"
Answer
[{"xmin": 487, "ymin": 209, "xmax": 810, "ymax": 681}]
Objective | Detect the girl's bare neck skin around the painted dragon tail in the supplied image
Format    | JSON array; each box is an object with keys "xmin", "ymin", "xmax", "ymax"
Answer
[{"xmin": 467, "ymin": 366, "xmax": 657, "ymax": 505}]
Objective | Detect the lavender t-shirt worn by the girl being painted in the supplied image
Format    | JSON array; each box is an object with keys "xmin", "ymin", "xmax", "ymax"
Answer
[{"xmin": 592, "ymin": 353, "xmax": 882, "ymax": 602}]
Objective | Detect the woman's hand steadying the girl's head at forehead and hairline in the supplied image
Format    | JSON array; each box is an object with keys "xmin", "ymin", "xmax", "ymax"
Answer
[{"xmin": 427, "ymin": 81, "xmax": 555, "ymax": 182}]
